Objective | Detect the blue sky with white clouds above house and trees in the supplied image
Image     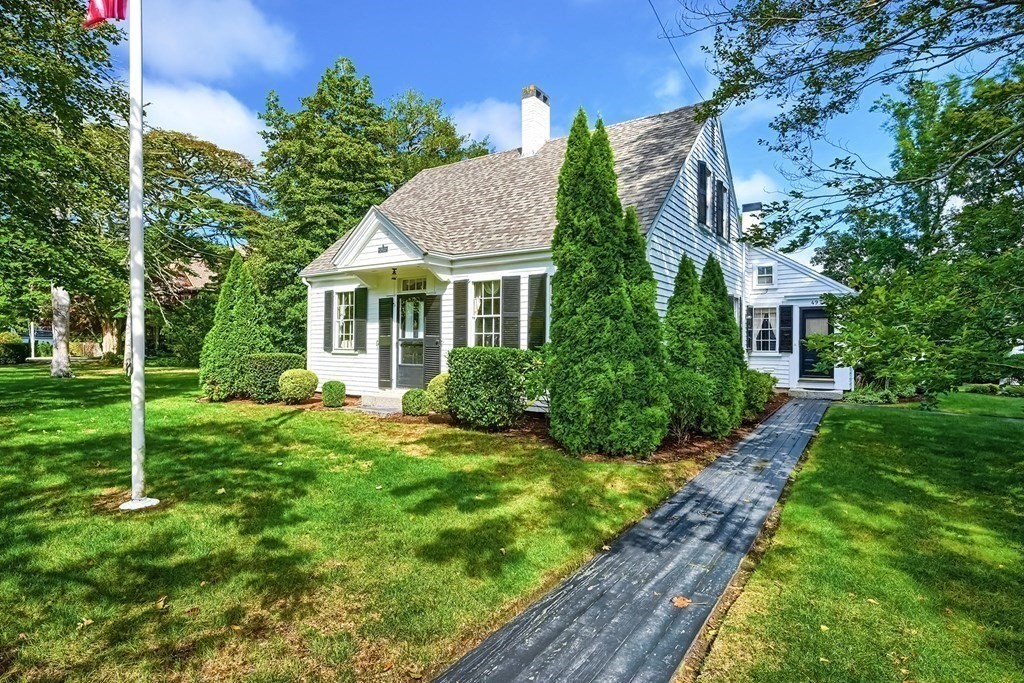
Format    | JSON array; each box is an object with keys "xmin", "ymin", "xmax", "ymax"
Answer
[{"xmin": 119, "ymin": 0, "xmax": 888, "ymax": 232}]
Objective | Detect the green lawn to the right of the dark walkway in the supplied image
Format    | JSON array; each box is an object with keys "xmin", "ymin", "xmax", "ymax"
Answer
[{"xmin": 699, "ymin": 394, "xmax": 1024, "ymax": 683}]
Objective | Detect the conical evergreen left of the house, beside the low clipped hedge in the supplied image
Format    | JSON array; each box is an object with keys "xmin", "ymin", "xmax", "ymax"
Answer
[{"xmin": 199, "ymin": 254, "xmax": 270, "ymax": 400}]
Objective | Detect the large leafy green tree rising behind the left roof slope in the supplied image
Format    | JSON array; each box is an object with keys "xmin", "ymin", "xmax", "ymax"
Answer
[{"xmin": 249, "ymin": 59, "xmax": 486, "ymax": 352}]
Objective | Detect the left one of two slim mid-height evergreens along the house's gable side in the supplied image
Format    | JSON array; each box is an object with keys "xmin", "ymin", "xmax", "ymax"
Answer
[{"xmin": 664, "ymin": 254, "xmax": 714, "ymax": 438}]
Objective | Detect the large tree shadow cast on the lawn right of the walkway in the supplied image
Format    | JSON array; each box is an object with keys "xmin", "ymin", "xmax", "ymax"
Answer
[{"xmin": 772, "ymin": 411, "xmax": 1024, "ymax": 671}]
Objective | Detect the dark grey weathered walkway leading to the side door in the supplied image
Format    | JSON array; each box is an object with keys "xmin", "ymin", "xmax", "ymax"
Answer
[{"xmin": 436, "ymin": 398, "xmax": 828, "ymax": 683}]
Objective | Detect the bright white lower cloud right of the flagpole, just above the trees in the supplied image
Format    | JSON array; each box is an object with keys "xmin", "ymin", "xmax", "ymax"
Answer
[{"xmin": 143, "ymin": 81, "xmax": 263, "ymax": 161}]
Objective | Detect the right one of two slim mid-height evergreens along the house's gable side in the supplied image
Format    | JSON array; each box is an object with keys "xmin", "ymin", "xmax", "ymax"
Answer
[{"xmin": 700, "ymin": 256, "xmax": 746, "ymax": 438}]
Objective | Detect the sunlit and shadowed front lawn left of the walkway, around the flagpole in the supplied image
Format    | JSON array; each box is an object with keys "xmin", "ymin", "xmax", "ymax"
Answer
[{"xmin": 0, "ymin": 367, "xmax": 696, "ymax": 681}]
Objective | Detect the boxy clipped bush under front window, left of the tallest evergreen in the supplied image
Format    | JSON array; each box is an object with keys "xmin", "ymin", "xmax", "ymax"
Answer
[{"xmin": 447, "ymin": 346, "xmax": 541, "ymax": 429}]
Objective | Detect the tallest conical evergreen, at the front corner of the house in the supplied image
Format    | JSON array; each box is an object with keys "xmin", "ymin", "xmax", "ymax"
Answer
[{"xmin": 549, "ymin": 110, "xmax": 668, "ymax": 455}]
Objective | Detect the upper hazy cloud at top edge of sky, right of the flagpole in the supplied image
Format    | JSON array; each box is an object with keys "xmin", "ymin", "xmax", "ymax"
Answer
[{"xmin": 143, "ymin": 0, "xmax": 299, "ymax": 81}]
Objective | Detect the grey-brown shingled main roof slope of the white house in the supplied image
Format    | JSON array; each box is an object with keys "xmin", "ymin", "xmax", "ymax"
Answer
[{"xmin": 302, "ymin": 106, "xmax": 700, "ymax": 275}]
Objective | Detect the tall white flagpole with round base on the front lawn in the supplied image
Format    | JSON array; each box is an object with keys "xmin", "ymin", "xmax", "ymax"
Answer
[{"xmin": 121, "ymin": 0, "xmax": 160, "ymax": 510}]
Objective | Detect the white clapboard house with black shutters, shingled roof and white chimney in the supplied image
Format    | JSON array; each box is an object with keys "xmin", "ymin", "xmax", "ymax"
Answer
[{"xmin": 301, "ymin": 86, "xmax": 852, "ymax": 400}]
